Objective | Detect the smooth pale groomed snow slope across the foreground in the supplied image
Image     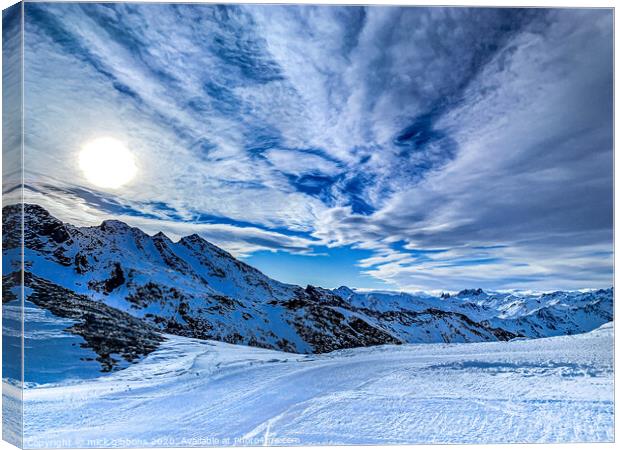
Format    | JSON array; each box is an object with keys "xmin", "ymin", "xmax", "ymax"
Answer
[{"xmin": 13, "ymin": 323, "xmax": 614, "ymax": 447}]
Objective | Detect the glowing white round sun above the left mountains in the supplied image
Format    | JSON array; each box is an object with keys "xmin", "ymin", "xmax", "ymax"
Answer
[{"xmin": 79, "ymin": 137, "xmax": 138, "ymax": 188}]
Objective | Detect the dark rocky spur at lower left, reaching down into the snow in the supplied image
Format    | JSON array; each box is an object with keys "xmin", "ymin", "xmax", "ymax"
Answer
[{"xmin": 2, "ymin": 272, "xmax": 165, "ymax": 372}]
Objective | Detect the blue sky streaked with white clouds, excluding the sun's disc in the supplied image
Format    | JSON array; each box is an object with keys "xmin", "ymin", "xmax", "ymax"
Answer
[{"xmin": 15, "ymin": 3, "xmax": 613, "ymax": 291}]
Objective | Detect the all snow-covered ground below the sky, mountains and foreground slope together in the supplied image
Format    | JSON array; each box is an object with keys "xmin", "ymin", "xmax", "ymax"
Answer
[{"xmin": 3, "ymin": 205, "xmax": 613, "ymax": 448}]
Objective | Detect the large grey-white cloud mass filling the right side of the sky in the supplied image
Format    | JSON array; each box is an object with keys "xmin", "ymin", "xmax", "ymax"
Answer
[{"xmin": 316, "ymin": 9, "xmax": 613, "ymax": 289}]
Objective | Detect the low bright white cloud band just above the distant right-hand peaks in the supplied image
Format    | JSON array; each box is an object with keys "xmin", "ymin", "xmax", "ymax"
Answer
[{"xmin": 362, "ymin": 245, "xmax": 613, "ymax": 291}]
